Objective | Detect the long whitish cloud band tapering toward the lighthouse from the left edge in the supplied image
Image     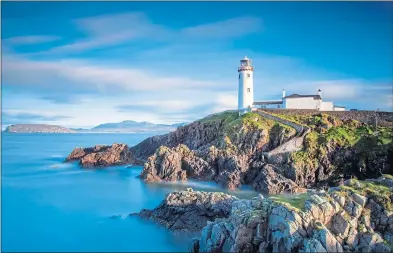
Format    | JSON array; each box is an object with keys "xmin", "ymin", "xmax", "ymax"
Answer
[{"xmin": 3, "ymin": 56, "xmax": 217, "ymax": 96}]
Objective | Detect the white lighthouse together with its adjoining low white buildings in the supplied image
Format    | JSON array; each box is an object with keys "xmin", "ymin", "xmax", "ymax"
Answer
[{"xmin": 238, "ymin": 56, "xmax": 345, "ymax": 112}]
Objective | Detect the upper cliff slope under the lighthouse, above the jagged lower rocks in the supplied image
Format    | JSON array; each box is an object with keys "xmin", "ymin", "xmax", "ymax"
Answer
[{"xmin": 131, "ymin": 112, "xmax": 295, "ymax": 161}]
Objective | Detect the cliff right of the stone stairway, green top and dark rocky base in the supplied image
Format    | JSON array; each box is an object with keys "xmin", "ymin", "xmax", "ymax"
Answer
[{"xmin": 282, "ymin": 114, "xmax": 393, "ymax": 187}]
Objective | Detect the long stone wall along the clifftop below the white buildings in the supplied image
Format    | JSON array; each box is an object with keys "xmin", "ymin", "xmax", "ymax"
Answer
[{"xmin": 258, "ymin": 109, "xmax": 393, "ymax": 127}]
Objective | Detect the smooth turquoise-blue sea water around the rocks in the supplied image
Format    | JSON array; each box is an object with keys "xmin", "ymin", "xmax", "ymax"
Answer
[{"xmin": 1, "ymin": 133, "xmax": 256, "ymax": 252}]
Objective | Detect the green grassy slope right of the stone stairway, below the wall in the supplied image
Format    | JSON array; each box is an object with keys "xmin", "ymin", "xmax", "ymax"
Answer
[{"xmin": 276, "ymin": 114, "xmax": 393, "ymax": 172}]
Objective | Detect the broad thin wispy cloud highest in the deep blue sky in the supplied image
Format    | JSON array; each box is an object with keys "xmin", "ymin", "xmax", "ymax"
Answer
[{"xmin": 13, "ymin": 12, "xmax": 262, "ymax": 56}]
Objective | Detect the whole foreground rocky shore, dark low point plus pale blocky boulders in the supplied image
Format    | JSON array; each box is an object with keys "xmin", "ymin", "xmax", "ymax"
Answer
[{"xmin": 133, "ymin": 176, "xmax": 393, "ymax": 253}]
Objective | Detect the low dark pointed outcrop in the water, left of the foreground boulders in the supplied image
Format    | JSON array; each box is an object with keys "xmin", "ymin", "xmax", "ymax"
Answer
[{"xmin": 131, "ymin": 189, "xmax": 237, "ymax": 232}]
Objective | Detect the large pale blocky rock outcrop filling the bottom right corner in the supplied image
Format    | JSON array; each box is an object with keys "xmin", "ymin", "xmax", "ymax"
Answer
[{"xmin": 190, "ymin": 177, "xmax": 393, "ymax": 252}]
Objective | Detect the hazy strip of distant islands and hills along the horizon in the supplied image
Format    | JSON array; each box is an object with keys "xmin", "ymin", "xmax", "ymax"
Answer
[{"xmin": 4, "ymin": 120, "xmax": 186, "ymax": 133}]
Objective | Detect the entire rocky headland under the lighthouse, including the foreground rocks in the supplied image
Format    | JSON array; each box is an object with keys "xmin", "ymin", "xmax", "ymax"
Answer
[{"xmin": 66, "ymin": 109, "xmax": 393, "ymax": 252}]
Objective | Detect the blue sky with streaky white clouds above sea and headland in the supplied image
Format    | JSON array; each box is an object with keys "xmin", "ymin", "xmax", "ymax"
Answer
[{"xmin": 2, "ymin": 2, "xmax": 393, "ymax": 127}]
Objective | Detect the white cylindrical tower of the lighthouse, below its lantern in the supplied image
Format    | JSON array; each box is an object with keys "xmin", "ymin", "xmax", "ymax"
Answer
[{"xmin": 238, "ymin": 70, "xmax": 254, "ymax": 109}]
